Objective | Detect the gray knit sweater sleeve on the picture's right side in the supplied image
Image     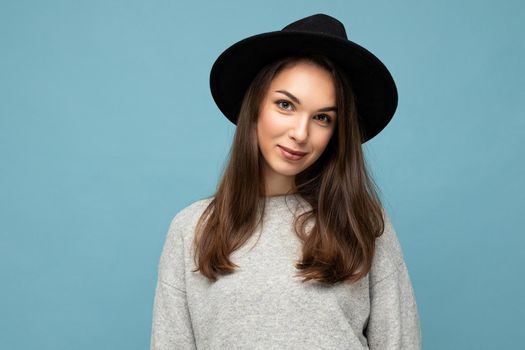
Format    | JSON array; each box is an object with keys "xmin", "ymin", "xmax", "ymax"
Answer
[{"xmin": 365, "ymin": 213, "xmax": 421, "ymax": 350}]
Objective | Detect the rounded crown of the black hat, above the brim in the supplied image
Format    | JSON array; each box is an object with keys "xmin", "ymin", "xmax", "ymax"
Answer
[{"xmin": 282, "ymin": 13, "xmax": 348, "ymax": 39}]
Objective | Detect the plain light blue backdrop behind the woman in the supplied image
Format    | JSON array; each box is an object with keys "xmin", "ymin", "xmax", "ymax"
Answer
[{"xmin": 0, "ymin": 0, "xmax": 525, "ymax": 349}]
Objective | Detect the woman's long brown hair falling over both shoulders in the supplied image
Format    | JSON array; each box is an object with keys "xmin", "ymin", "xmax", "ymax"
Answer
[{"xmin": 193, "ymin": 54, "xmax": 385, "ymax": 284}]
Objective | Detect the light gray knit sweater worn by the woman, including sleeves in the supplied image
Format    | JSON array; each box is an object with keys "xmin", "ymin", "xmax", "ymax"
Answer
[{"xmin": 151, "ymin": 195, "xmax": 421, "ymax": 350}]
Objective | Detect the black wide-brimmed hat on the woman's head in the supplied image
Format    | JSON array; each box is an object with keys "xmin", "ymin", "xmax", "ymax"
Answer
[{"xmin": 210, "ymin": 14, "xmax": 398, "ymax": 143}]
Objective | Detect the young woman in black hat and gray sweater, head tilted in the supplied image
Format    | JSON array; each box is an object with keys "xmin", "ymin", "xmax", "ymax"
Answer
[{"xmin": 151, "ymin": 14, "xmax": 421, "ymax": 350}]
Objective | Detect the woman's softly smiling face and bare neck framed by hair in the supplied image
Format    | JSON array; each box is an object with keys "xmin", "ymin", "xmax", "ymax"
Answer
[{"xmin": 257, "ymin": 61, "xmax": 337, "ymax": 196}]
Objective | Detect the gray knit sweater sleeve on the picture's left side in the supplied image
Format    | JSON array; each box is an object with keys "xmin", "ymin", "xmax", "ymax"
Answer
[{"xmin": 150, "ymin": 214, "xmax": 197, "ymax": 350}]
